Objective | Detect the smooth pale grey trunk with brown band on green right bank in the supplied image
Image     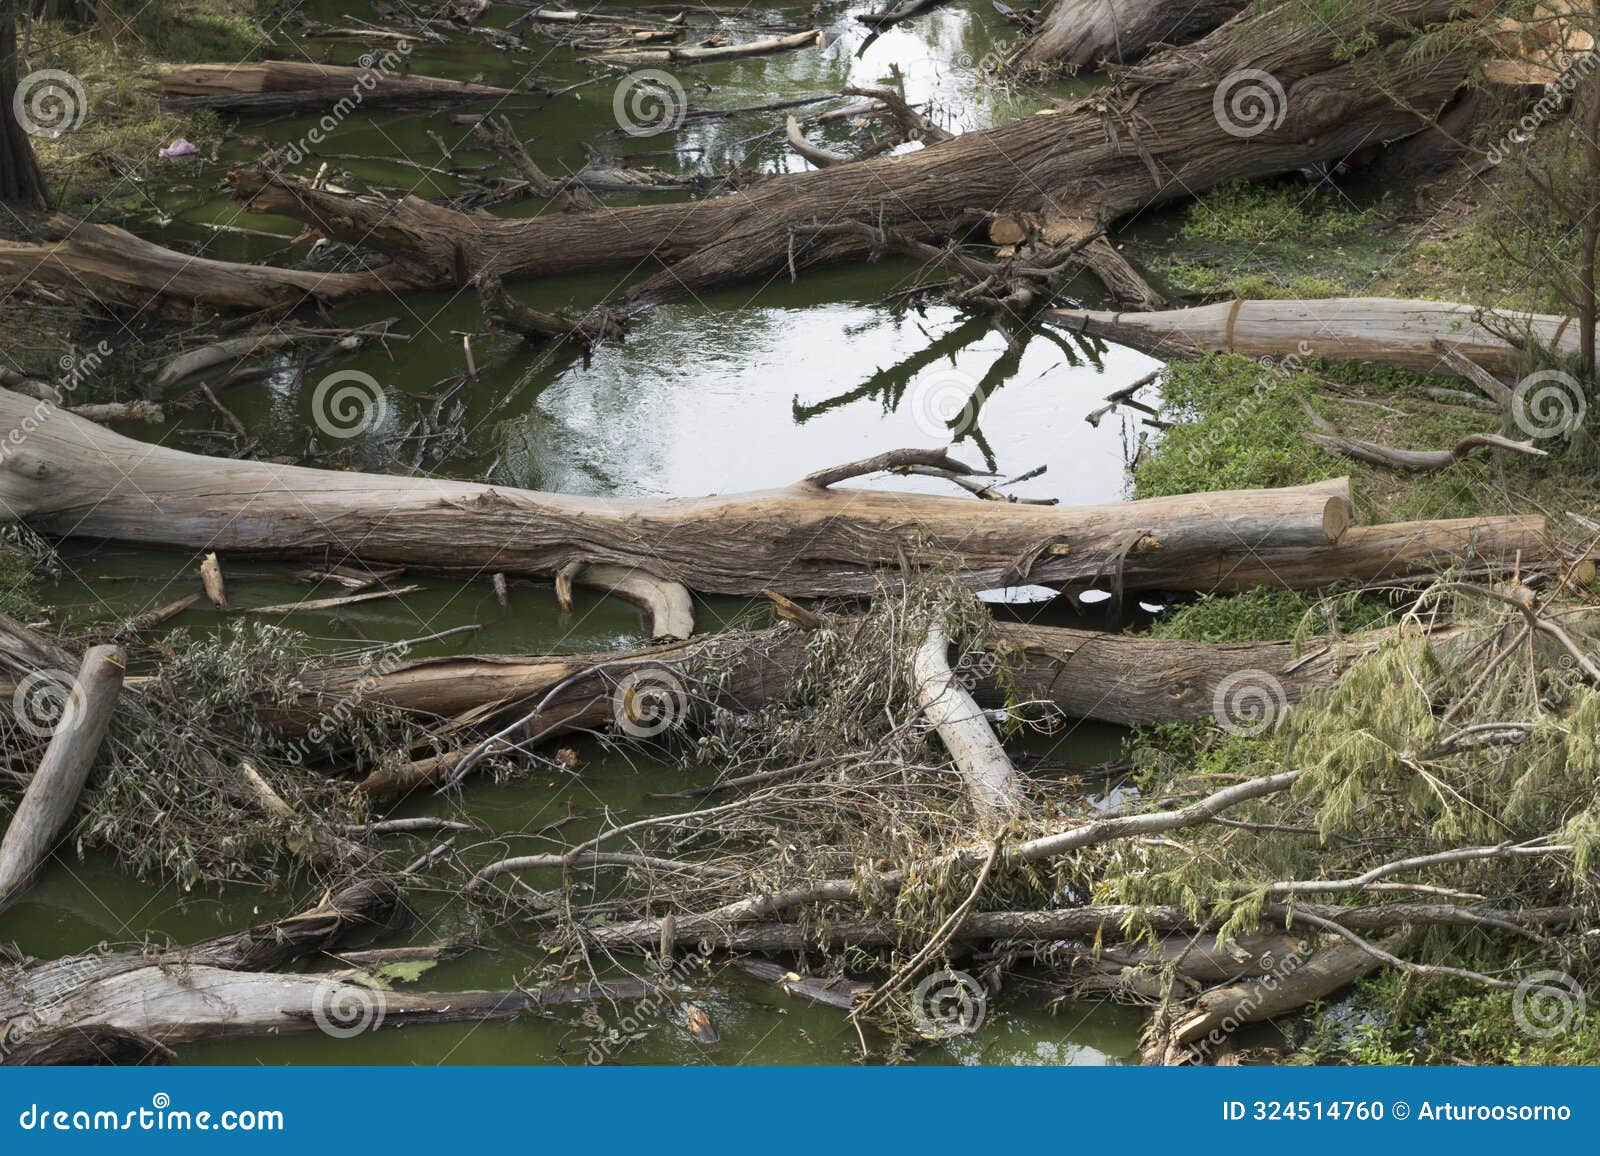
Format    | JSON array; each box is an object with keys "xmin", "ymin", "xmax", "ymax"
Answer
[{"xmin": 1045, "ymin": 298, "xmax": 1578, "ymax": 376}]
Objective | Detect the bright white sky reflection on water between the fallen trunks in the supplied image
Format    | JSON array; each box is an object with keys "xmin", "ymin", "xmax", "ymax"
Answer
[{"xmin": 507, "ymin": 304, "xmax": 1155, "ymax": 504}]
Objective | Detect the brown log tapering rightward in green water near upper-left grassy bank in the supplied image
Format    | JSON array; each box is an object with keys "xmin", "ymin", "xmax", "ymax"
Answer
[{"xmin": 160, "ymin": 61, "xmax": 515, "ymax": 112}]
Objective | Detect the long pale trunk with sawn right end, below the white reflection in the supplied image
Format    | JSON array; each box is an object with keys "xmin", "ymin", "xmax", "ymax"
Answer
[{"xmin": 0, "ymin": 391, "xmax": 1369, "ymax": 597}]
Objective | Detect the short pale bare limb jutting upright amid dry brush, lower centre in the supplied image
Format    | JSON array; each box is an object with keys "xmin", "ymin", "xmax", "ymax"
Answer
[{"xmin": 910, "ymin": 626, "xmax": 1022, "ymax": 826}]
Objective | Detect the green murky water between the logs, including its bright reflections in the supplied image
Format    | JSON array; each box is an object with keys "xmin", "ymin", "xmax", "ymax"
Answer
[{"xmin": 0, "ymin": 0, "xmax": 1154, "ymax": 1063}]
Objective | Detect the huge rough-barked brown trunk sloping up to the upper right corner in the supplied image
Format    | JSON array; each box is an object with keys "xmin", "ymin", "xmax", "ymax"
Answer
[{"xmin": 0, "ymin": 0, "xmax": 1466, "ymax": 309}]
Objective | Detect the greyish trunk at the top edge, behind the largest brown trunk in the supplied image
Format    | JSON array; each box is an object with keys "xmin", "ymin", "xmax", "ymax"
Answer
[{"xmin": 1018, "ymin": 0, "xmax": 1248, "ymax": 69}]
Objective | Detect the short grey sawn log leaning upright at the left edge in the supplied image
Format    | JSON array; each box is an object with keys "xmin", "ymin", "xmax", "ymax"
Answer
[{"xmin": 0, "ymin": 647, "xmax": 123, "ymax": 911}]
